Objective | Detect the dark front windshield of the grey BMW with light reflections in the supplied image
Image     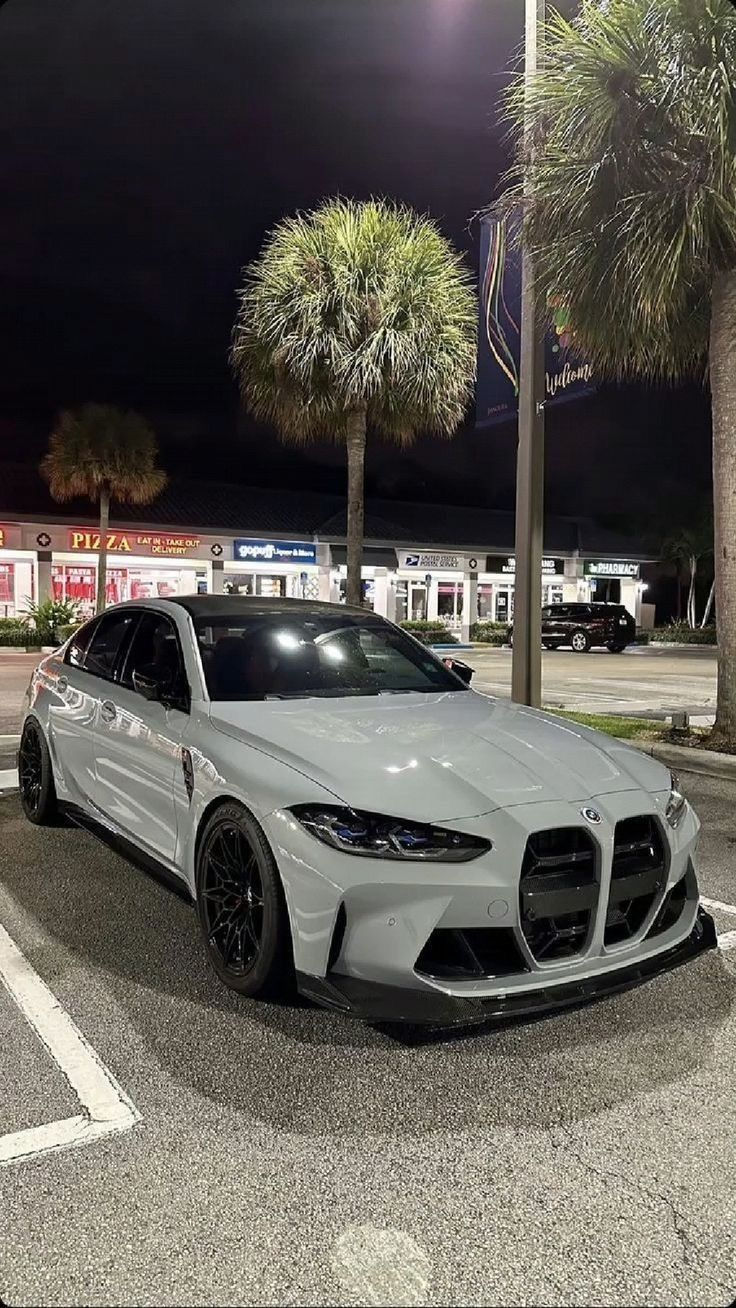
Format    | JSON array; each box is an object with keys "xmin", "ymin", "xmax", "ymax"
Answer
[{"xmin": 195, "ymin": 611, "xmax": 467, "ymax": 700}]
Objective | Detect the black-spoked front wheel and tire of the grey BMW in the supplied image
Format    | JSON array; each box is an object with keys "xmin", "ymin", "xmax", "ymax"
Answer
[{"xmin": 196, "ymin": 802, "xmax": 293, "ymax": 997}]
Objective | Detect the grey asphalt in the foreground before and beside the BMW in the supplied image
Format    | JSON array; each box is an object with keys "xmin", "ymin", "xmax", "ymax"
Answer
[{"xmin": 0, "ymin": 777, "xmax": 736, "ymax": 1305}]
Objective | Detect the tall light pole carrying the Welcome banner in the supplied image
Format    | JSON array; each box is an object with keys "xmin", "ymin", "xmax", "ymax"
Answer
[{"xmin": 511, "ymin": 0, "xmax": 545, "ymax": 708}]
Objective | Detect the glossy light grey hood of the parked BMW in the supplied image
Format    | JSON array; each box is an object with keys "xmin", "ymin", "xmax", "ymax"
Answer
[{"xmin": 210, "ymin": 691, "xmax": 669, "ymax": 821}]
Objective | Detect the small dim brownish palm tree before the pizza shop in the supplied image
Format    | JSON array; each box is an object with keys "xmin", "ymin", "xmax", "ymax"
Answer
[{"xmin": 41, "ymin": 404, "xmax": 166, "ymax": 613}]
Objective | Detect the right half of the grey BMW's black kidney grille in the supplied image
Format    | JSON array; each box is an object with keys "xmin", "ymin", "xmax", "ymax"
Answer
[{"xmin": 604, "ymin": 815, "xmax": 667, "ymax": 944}]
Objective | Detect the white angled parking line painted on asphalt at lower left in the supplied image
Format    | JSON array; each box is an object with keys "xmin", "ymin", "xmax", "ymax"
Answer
[{"xmin": 0, "ymin": 926, "xmax": 140, "ymax": 1167}]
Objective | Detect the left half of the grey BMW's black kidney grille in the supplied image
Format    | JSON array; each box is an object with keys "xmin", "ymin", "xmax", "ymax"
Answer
[{"xmin": 519, "ymin": 827, "xmax": 599, "ymax": 963}]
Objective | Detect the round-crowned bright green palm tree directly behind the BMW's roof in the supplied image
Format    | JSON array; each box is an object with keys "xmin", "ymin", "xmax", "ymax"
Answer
[{"xmin": 231, "ymin": 199, "xmax": 477, "ymax": 604}]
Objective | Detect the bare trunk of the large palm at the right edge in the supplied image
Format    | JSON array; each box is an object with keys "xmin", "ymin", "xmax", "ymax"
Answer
[{"xmin": 710, "ymin": 268, "xmax": 736, "ymax": 751}]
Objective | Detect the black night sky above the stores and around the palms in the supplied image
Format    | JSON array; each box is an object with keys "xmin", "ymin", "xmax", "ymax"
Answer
[{"xmin": 0, "ymin": 0, "xmax": 710, "ymax": 517}]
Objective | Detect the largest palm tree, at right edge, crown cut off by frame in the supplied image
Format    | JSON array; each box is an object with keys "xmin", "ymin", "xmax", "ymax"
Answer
[{"xmin": 507, "ymin": 0, "xmax": 736, "ymax": 749}]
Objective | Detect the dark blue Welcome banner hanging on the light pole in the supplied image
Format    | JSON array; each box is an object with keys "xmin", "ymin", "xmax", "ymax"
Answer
[{"xmin": 476, "ymin": 207, "xmax": 595, "ymax": 426}]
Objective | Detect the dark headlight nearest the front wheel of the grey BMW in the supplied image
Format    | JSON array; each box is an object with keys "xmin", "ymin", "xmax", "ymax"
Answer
[{"xmin": 290, "ymin": 804, "xmax": 492, "ymax": 863}]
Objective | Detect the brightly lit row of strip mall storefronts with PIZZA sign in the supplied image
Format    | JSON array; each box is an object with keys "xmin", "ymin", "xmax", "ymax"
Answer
[{"xmin": 0, "ymin": 522, "xmax": 646, "ymax": 640}]
